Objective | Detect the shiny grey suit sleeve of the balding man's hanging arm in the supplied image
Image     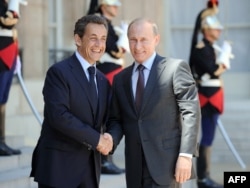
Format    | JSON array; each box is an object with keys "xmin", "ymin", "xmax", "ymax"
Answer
[{"xmin": 173, "ymin": 61, "xmax": 201, "ymax": 156}]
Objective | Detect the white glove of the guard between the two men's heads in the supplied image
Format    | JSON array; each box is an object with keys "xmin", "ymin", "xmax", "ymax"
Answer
[{"xmin": 115, "ymin": 21, "xmax": 130, "ymax": 52}]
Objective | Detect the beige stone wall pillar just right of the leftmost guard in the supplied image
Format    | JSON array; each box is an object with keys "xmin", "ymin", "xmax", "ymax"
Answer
[{"xmin": 17, "ymin": 0, "xmax": 48, "ymax": 78}]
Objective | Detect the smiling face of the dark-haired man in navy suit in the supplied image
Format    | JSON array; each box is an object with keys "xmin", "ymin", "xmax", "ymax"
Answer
[{"xmin": 75, "ymin": 23, "xmax": 107, "ymax": 64}]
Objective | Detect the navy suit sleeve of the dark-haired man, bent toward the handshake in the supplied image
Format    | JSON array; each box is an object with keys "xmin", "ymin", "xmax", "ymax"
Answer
[{"xmin": 43, "ymin": 66, "xmax": 100, "ymax": 149}]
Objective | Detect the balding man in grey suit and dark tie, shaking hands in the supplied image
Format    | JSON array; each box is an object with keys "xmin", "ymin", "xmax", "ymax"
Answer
[{"xmin": 107, "ymin": 18, "xmax": 200, "ymax": 188}]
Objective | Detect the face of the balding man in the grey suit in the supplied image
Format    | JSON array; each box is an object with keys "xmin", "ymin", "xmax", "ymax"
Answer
[{"xmin": 128, "ymin": 22, "xmax": 160, "ymax": 63}]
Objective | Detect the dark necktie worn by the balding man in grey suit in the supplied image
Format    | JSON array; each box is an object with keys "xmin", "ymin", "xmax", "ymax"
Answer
[{"xmin": 135, "ymin": 65, "xmax": 145, "ymax": 112}]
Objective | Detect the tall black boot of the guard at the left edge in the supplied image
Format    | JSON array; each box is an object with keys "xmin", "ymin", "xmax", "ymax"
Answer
[{"xmin": 0, "ymin": 105, "xmax": 21, "ymax": 156}]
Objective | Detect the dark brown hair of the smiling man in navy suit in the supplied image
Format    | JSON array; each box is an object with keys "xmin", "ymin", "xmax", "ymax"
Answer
[{"xmin": 74, "ymin": 14, "xmax": 108, "ymax": 38}]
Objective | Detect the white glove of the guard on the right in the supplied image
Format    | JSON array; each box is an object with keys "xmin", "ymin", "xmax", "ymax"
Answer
[{"xmin": 217, "ymin": 41, "xmax": 233, "ymax": 69}]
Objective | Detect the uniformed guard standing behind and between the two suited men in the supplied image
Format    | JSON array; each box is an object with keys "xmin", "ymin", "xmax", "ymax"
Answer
[{"xmin": 88, "ymin": 0, "xmax": 129, "ymax": 174}]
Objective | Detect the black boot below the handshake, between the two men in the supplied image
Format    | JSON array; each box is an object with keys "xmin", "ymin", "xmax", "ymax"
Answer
[{"xmin": 101, "ymin": 155, "xmax": 125, "ymax": 174}]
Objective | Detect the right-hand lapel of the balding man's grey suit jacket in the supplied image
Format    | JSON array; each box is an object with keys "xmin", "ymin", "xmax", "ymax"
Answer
[{"xmin": 141, "ymin": 55, "xmax": 166, "ymax": 111}]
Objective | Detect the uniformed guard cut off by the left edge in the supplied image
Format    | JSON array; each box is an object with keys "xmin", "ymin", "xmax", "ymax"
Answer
[{"xmin": 0, "ymin": 0, "xmax": 26, "ymax": 156}]
